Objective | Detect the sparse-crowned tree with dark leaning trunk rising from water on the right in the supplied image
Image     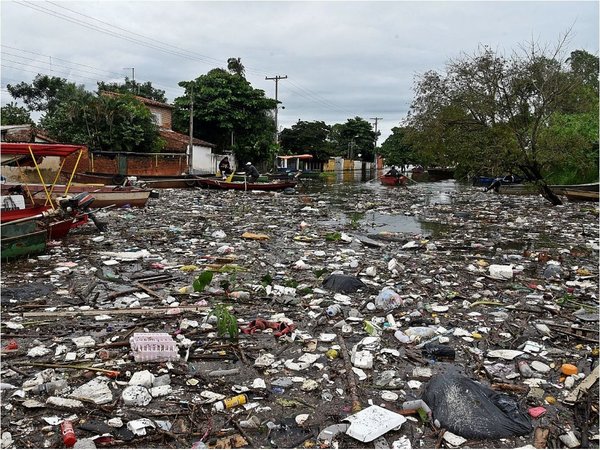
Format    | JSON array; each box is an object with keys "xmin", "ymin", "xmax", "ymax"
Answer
[{"xmin": 409, "ymin": 36, "xmax": 596, "ymax": 204}]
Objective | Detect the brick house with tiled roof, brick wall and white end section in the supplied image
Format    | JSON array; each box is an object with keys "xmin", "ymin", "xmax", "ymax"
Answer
[{"xmin": 63, "ymin": 91, "xmax": 231, "ymax": 178}]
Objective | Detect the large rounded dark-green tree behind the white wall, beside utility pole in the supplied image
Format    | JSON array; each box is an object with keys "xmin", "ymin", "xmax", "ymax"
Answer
[{"xmin": 173, "ymin": 69, "xmax": 278, "ymax": 162}]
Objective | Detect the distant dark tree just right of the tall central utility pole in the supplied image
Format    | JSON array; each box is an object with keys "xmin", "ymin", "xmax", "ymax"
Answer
[{"xmin": 279, "ymin": 120, "xmax": 333, "ymax": 161}]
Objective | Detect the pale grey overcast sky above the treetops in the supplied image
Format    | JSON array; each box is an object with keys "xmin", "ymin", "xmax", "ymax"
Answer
[{"xmin": 0, "ymin": 0, "xmax": 599, "ymax": 143}]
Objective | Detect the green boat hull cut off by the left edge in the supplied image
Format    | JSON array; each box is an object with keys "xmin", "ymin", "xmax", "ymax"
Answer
[{"xmin": 0, "ymin": 219, "xmax": 48, "ymax": 260}]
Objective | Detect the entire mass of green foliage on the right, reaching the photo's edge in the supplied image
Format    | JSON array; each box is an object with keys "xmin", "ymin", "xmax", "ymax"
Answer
[{"xmin": 408, "ymin": 37, "xmax": 598, "ymax": 182}]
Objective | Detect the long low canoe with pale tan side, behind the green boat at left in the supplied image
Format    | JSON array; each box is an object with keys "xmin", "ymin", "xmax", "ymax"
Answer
[{"xmin": 2, "ymin": 183, "xmax": 153, "ymax": 208}]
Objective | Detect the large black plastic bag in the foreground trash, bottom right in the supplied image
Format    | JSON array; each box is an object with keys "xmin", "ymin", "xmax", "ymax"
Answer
[{"xmin": 422, "ymin": 371, "xmax": 532, "ymax": 439}]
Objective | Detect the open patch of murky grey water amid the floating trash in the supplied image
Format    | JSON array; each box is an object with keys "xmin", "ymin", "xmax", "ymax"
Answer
[{"xmin": 299, "ymin": 172, "xmax": 467, "ymax": 234}]
